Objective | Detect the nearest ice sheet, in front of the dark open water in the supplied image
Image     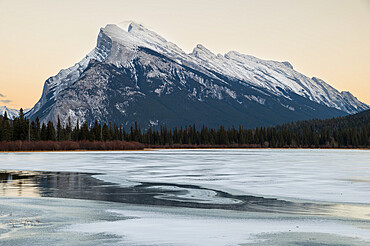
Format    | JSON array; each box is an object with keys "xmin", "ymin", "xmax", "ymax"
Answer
[{"xmin": 0, "ymin": 197, "xmax": 370, "ymax": 246}]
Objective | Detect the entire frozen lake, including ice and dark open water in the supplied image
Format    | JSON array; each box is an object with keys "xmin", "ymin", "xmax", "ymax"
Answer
[{"xmin": 0, "ymin": 149, "xmax": 370, "ymax": 245}]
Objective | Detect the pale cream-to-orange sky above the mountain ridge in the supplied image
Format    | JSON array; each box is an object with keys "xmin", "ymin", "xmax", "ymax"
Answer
[{"xmin": 0, "ymin": 0, "xmax": 370, "ymax": 108}]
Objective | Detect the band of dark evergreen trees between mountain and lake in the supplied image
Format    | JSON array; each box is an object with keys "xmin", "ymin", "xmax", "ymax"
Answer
[{"xmin": 0, "ymin": 109, "xmax": 370, "ymax": 148}]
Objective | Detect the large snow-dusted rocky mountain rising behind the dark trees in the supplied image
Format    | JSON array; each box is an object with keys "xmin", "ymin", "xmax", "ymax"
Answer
[{"xmin": 26, "ymin": 23, "xmax": 369, "ymax": 128}]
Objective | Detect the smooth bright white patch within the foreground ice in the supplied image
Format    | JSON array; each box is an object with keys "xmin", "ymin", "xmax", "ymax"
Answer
[{"xmin": 67, "ymin": 209, "xmax": 370, "ymax": 246}]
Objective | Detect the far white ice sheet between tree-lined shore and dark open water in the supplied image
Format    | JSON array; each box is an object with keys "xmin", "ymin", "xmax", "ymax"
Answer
[{"xmin": 0, "ymin": 149, "xmax": 370, "ymax": 204}]
